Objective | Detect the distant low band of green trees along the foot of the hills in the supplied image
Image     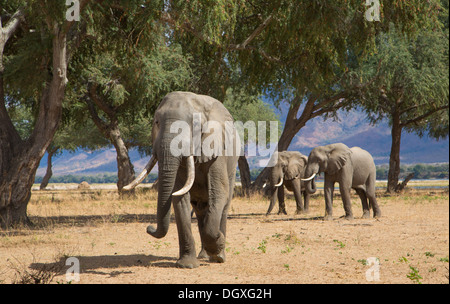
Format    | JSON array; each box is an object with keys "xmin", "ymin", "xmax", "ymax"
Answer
[{"xmin": 35, "ymin": 163, "xmax": 449, "ymax": 184}]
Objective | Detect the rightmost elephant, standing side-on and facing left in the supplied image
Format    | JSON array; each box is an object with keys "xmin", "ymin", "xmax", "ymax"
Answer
[{"xmin": 303, "ymin": 143, "xmax": 381, "ymax": 219}]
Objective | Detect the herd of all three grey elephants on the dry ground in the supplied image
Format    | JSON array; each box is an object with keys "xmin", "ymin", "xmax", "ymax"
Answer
[{"xmin": 123, "ymin": 92, "xmax": 381, "ymax": 268}]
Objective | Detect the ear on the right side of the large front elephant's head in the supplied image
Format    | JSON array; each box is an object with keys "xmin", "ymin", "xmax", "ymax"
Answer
[{"xmin": 193, "ymin": 95, "xmax": 236, "ymax": 163}]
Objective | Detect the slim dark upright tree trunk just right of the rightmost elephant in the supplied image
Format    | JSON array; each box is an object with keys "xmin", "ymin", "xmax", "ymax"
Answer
[{"xmin": 386, "ymin": 113, "xmax": 402, "ymax": 193}]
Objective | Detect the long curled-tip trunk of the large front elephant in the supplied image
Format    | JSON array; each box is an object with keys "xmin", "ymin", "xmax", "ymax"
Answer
[{"xmin": 147, "ymin": 141, "xmax": 181, "ymax": 238}]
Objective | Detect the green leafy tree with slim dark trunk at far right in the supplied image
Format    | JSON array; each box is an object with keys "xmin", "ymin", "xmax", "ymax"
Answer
[{"xmin": 360, "ymin": 22, "xmax": 449, "ymax": 192}]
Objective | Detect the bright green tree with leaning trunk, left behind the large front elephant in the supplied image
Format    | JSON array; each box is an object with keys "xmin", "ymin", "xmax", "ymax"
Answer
[{"xmin": 69, "ymin": 1, "xmax": 190, "ymax": 194}]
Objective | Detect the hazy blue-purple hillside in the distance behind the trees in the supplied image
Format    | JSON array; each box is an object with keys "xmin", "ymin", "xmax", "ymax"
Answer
[{"xmin": 37, "ymin": 105, "xmax": 449, "ymax": 176}]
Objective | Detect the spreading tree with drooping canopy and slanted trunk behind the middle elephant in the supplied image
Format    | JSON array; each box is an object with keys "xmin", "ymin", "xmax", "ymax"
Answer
[{"xmin": 163, "ymin": 0, "xmax": 438, "ymax": 188}]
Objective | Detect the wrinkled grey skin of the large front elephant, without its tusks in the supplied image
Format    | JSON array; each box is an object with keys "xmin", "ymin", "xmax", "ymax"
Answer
[{"xmin": 130, "ymin": 92, "xmax": 239, "ymax": 268}]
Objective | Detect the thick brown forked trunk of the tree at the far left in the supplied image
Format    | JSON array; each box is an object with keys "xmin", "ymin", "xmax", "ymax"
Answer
[{"xmin": 0, "ymin": 23, "xmax": 67, "ymax": 228}]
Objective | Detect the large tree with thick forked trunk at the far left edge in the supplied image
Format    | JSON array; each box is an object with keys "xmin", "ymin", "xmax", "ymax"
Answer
[{"xmin": 0, "ymin": 1, "xmax": 92, "ymax": 227}]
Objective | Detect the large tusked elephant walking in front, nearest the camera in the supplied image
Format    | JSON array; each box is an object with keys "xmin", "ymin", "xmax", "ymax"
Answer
[{"xmin": 124, "ymin": 92, "xmax": 240, "ymax": 268}]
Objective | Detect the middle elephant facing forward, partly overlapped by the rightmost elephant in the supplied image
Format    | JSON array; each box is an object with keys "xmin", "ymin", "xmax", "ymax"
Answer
[{"xmin": 266, "ymin": 151, "xmax": 314, "ymax": 215}]
